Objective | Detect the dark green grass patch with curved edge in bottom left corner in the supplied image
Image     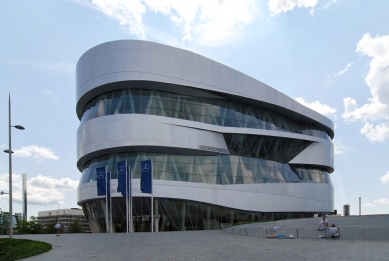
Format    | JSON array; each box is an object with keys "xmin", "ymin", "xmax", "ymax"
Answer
[{"xmin": 0, "ymin": 238, "xmax": 52, "ymax": 261}]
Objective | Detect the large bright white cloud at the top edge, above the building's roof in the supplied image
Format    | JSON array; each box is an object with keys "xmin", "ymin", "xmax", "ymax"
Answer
[{"xmin": 74, "ymin": 0, "xmax": 258, "ymax": 46}]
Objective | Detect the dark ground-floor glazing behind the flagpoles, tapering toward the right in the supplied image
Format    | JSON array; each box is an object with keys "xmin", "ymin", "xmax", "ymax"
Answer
[{"xmin": 81, "ymin": 197, "xmax": 320, "ymax": 233}]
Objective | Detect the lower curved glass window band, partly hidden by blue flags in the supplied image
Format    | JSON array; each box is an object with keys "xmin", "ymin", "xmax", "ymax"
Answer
[{"xmin": 80, "ymin": 152, "xmax": 332, "ymax": 185}]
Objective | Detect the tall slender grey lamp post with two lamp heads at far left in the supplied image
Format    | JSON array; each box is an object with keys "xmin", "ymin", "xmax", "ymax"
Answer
[{"xmin": 4, "ymin": 94, "xmax": 24, "ymax": 238}]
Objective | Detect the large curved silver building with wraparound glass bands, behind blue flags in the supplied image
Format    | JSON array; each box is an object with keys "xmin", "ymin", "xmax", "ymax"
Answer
[{"xmin": 76, "ymin": 40, "xmax": 334, "ymax": 232}]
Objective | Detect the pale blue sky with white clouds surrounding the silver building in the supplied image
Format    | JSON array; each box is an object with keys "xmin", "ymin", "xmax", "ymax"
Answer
[{"xmin": 0, "ymin": 0, "xmax": 389, "ymax": 216}]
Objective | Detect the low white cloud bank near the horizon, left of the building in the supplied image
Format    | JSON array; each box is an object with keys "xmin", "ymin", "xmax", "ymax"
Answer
[{"xmin": 0, "ymin": 174, "xmax": 78, "ymax": 205}]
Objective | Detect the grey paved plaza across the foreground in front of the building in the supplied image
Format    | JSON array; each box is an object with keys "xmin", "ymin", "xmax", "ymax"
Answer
[{"xmin": 1, "ymin": 231, "xmax": 389, "ymax": 261}]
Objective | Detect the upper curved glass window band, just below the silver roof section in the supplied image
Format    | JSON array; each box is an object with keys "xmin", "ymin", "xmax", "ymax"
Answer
[{"xmin": 81, "ymin": 89, "xmax": 330, "ymax": 139}]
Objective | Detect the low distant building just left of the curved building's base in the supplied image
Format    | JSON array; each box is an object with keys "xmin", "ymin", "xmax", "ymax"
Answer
[{"xmin": 38, "ymin": 208, "xmax": 91, "ymax": 233}]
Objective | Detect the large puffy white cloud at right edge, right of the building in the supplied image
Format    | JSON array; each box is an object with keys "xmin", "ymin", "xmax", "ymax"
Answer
[{"xmin": 342, "ymin": 34, "xmax": 389, "ymax": 141}]
